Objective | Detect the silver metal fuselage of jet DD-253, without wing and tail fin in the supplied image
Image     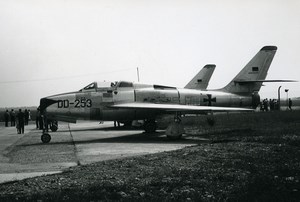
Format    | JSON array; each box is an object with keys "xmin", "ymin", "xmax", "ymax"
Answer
[{"xmin": 46, "ymin": 83, "xmax": 259, "ymax": 122}]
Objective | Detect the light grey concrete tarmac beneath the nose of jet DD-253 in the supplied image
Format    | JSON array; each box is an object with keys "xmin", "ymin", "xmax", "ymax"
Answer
[{"xmin": 0, "ymin": 122, "xmax": 205, "ymax": 183}]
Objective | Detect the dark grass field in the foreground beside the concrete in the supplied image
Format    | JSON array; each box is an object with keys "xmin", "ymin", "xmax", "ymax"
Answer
[{"xmin": 0, "ymin": 111, "xmax": 300, "ymax": 201}]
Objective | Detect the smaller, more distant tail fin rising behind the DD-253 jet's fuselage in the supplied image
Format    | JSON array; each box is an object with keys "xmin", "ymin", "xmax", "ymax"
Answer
[{"xmin": 184, "ymin": 64, "xmax": 216, "ymax": 90}]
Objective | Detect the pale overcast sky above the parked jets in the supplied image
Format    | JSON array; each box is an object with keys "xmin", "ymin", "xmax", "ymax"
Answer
[{"xmin": 0, "ymin": 0, "xmax": 300, "ymax": 107}]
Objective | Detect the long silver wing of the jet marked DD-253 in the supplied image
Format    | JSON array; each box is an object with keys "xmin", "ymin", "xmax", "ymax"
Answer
[{"xmin": 110, "ymin": 102, "xmax": 253, "ymax": 112}]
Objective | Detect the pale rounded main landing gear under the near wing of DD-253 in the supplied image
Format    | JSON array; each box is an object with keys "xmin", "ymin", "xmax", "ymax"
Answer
[{"xmin": 166, "ymin": 112, "xmax": 184, "ymax": 140}]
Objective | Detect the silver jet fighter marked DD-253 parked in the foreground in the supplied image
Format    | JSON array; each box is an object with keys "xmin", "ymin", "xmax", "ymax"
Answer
[{"xmin": 40, "ymin": 46, "xmax": 284, "ymax": 143}]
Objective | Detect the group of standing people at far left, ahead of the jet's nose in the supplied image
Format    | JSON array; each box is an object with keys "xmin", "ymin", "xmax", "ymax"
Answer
[{"xmin": 4, "ymin": 109, "xmax": 31, "ymax": 134}]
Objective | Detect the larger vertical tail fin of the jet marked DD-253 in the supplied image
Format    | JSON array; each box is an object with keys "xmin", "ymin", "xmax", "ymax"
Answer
[{"xmin": 222, "ymin": 46, "xmax": 277, "ymax": 94}]
